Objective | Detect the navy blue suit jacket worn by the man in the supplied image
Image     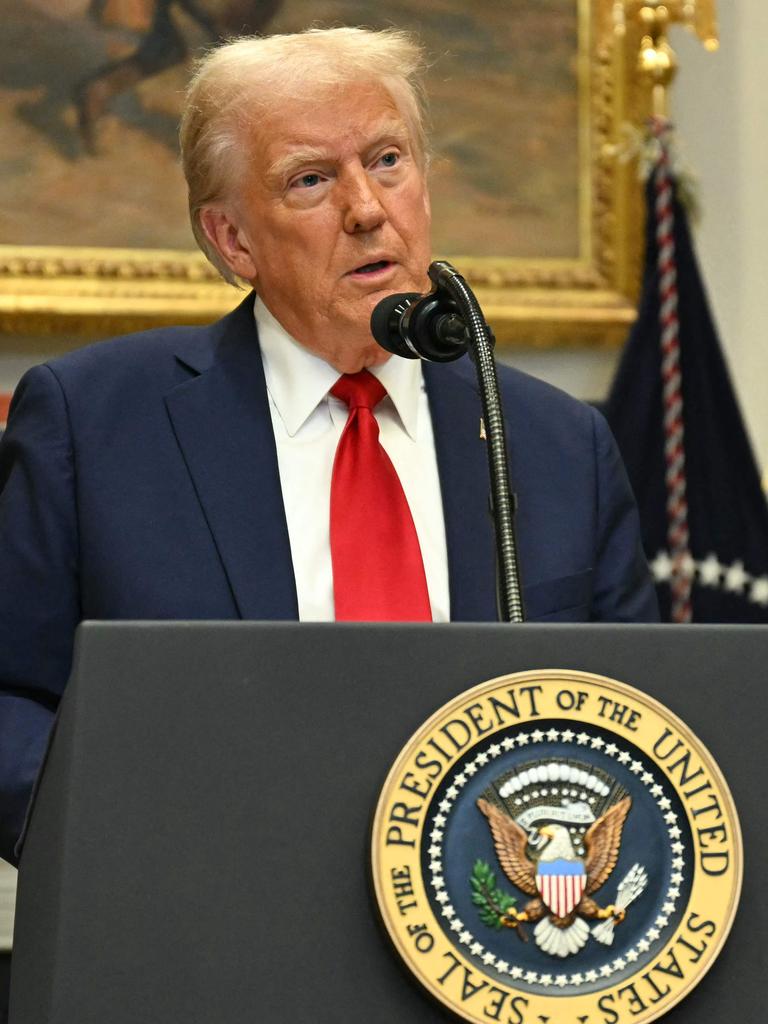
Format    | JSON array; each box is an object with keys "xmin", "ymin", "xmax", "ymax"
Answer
[{"xmin": 0, "ymin": 300, "xmax": 656, "ymax": 859}]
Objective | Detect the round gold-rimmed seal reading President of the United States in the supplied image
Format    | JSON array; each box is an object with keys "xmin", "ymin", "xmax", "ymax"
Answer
[{"xmin": 373, "ymin": 670, "xmax": 742, "ymax": 1024}]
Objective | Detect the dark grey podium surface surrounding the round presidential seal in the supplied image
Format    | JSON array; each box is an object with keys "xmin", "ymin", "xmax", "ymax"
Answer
[{"xmin": 10, "ymin": 623, "xmax": 768, "ymax": 1024}]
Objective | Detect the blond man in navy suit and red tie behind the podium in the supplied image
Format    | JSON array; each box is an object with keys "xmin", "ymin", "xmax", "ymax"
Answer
[{"xmin": 0, "ymin": 29, "xmax": 655, "ymax": 859}]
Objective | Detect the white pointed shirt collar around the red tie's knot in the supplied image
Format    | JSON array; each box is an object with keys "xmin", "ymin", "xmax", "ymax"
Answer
[{"xmin": 259, "ymin": 296, "xmax": 424, "ymax": 440}]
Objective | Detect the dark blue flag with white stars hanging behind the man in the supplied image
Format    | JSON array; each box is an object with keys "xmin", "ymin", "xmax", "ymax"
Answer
[{"xmin": 604, "ymin": 165, "xmax": 768, "ymax": 623}]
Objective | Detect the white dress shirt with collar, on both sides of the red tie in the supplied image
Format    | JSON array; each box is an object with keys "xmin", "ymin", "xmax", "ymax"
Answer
[{"xmin": 254, "ymin": 298, "xmax": 451, "ymax": 623}]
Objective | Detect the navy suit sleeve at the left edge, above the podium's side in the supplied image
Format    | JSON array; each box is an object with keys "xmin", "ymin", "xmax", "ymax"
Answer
[{"xmin": 0, "ymin": 367, "xmax": 80, "ymax": 863}]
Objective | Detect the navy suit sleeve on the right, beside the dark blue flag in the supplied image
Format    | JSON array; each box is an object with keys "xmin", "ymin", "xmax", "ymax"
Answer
[{"xmin": 592, "ymin": 410, "xmax": 658, "ymax": 623}]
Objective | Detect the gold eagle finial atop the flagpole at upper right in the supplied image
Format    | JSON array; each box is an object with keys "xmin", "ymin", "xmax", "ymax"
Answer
[{"xmin": 613, "ymin": 0, "xmax": 719, "ymax": 117}]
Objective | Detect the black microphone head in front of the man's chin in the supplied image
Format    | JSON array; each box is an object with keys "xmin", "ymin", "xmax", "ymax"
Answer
[{"xmin": 371, "ymin": 289, "xmax": 469, "ymax": 362}]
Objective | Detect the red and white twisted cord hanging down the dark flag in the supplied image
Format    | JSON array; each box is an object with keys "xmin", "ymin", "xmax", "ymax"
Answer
[{"xmin": 651, "ymin": 118, "xmax": 693, "ymax": 623}]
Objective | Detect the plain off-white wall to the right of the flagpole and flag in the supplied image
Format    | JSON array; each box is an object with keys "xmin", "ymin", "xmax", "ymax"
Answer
[{"xmin": 675, "ymin": 0, "xmax": 768, "ymax": 467}]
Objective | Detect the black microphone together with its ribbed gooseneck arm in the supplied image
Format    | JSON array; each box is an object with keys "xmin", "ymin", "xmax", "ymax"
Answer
[{"xmin": 371, "ymin": 260, "xmax": 525, "ymax": 623}]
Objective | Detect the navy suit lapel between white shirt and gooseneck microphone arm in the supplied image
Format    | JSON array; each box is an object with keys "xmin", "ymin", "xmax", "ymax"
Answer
[{"xmin": 424, "ymin": 359, "xmax": 497, "ymax": 622}]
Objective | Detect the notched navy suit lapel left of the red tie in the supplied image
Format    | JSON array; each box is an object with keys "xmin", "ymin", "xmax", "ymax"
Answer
[{"xmin": 166, "ymin": 298, "xmax": 298, "ymax": 620}]
